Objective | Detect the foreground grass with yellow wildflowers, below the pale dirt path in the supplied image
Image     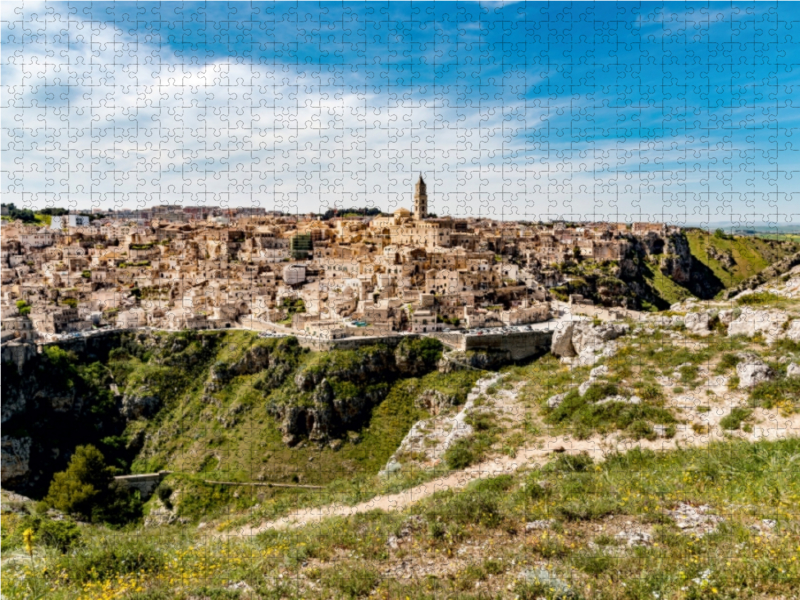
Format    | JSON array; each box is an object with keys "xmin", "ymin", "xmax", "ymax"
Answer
[{"xmin": 2, "ymin": 439, "xmax": 800, "ymax": 600}]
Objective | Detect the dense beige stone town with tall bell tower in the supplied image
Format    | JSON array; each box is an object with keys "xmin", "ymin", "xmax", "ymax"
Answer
[{"xmin": 0, "ymin": 176, "xmax": 675, "ymax": 341}]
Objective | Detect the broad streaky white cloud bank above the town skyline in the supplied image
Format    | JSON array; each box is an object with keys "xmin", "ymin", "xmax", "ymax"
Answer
[{"xmin": 2, "ymin": 2, "xmax": 790, "ymax": 225}]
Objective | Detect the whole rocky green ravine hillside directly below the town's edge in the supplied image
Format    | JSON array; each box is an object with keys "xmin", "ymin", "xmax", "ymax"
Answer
[{"xmin": 3, "ymin": 332, "xmax": 477, "ymax": 504}]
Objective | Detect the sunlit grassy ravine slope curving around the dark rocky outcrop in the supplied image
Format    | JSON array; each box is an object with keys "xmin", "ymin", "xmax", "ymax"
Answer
[{"xmin": 117, "ymin": 332, "xmax": 480, "ymax": 518}]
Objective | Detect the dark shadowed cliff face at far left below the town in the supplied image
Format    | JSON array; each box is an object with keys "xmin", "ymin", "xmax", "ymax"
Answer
[{"xmin": 2, "ymin": 332, "xmax": 225, "ymax": 496}]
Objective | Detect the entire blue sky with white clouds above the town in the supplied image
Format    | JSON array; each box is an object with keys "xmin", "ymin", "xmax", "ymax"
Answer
[{"xmin": 2, "ymin": 2, "xmax": 800, "ymax": 225}]
